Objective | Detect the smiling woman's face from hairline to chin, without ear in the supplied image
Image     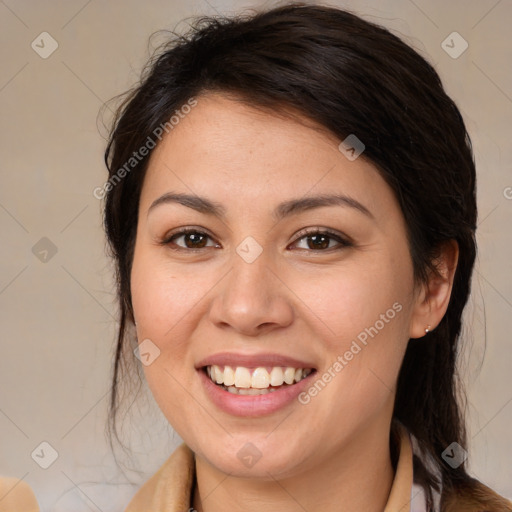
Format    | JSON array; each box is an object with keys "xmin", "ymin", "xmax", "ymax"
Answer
[{"xmin": 131, "ymin": 94, "xmax": 425, "ymax": 477}]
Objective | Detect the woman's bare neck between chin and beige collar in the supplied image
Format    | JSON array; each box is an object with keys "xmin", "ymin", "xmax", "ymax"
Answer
[{"xmin": 193, "ymin": 420, "xmax": 394, "ymax": 512}]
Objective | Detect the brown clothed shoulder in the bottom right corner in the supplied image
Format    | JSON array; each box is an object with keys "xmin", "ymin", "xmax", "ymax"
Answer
[{"xmin": 441, "ymin": 478, "xmax": 512, "ymax": 512}]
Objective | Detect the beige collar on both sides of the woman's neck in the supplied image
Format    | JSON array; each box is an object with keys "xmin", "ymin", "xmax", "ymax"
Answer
[{"xmin": 125, "ymin": 427, "xmax": 413, "ymax": 512}]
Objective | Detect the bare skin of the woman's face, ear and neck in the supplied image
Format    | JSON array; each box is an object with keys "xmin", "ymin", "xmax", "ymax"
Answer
[{"xmin": 131, "ymin": 93, "xmax": 458, "ymax": 512}]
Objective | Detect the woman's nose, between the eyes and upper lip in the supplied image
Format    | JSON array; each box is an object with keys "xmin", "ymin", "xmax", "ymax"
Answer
[{"xmin": 209, "ymin": 253, "xmax": 294, "ymax": 336}]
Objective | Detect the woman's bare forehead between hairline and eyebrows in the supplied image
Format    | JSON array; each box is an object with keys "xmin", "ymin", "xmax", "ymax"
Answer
[{"xmin": 141, "ymin": 94, "xmax": 393, "ymax": 217}]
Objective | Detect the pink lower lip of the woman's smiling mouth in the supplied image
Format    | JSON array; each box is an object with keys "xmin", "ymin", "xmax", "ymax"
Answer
[{"xmin": 198, "ymin": 369, "xmax": 315, "ymax": 417}]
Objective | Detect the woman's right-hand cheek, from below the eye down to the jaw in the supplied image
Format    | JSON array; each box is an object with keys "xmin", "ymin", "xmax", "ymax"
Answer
[{"xmin": 290, "ymin": 253, "xmax": 413, "ymax": 416}]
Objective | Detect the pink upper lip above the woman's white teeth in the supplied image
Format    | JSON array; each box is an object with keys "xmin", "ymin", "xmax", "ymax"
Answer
[{"xmin": 196, "ymin": 352, "xmax": 314, "ymax": 369}]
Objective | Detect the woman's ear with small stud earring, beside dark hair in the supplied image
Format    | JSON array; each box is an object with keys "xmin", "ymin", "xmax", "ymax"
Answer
[{"xmin": 409, "ymin": 240, "xmax": 459, "ymax": 338}]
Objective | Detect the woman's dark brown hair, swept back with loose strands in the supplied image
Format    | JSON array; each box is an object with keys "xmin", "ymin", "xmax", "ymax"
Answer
[{"xmin": 104, "ymin": 4, "xmax": 490, "ymax": 508}]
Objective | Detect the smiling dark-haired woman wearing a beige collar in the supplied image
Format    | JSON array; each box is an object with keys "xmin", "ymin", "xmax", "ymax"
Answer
[{"xmin": 2, "ymin": 4, "xmax": 512, "ymax": 512}]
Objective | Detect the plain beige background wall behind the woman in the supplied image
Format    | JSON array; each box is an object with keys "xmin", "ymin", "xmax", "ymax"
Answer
[{"xmin": 0, "ymin": 0, "xmax": 512, "ymax": 512}]
